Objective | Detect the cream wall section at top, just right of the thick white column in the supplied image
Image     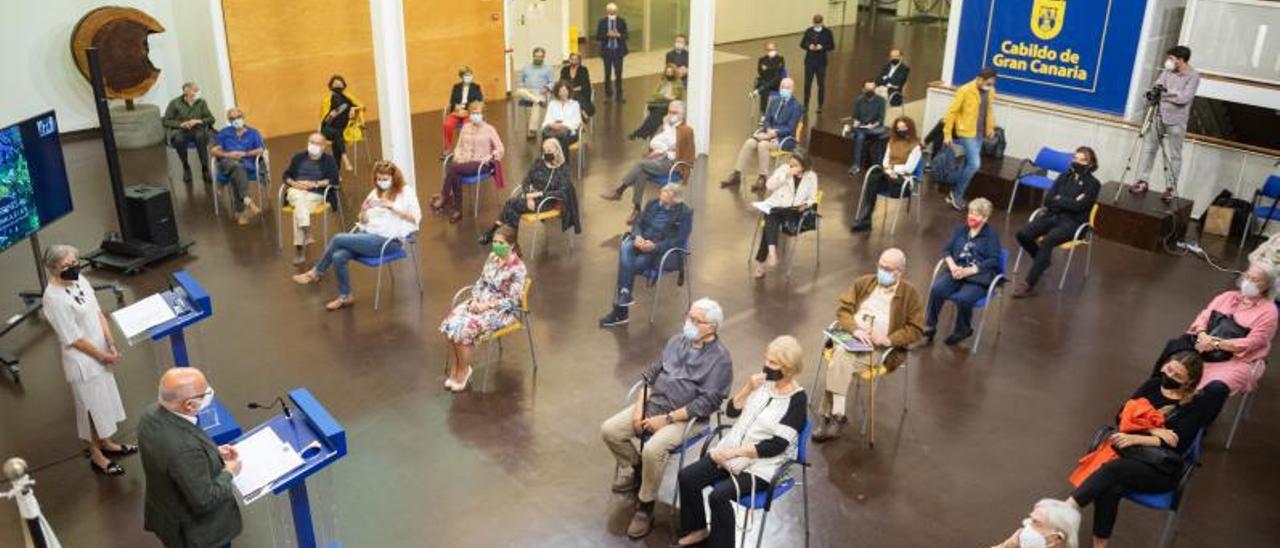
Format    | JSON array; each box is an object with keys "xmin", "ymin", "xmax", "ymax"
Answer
[{"xmin": 716, "ymin": 0, "xmax": 829, "ymax": 44}]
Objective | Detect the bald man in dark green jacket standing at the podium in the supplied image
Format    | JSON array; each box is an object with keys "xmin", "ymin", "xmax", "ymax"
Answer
[{"xmin": 138, "ymin": 367, "xmax": 242, "ymax": 548}]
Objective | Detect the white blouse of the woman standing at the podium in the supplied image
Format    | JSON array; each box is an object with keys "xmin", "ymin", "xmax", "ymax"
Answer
[{"xmin": 41, "ymin": 277, "xmax": 106, "ymax": 383}]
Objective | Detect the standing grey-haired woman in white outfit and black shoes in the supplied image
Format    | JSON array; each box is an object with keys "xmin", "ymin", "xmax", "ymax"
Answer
[{"xmin": 42, "ymin": 245, "xmax": 138, "ymax": 476}]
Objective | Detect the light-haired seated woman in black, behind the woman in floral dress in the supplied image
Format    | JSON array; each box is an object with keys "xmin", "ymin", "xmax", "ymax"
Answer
[{"xmin": 480, "ymin": 138, "xmax": 582, "ymax": 246}]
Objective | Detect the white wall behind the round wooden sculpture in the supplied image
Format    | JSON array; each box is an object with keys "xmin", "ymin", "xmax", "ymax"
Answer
[{"xmin": 0, "ymin": 0, "xmax": 204, "ymax": 132}]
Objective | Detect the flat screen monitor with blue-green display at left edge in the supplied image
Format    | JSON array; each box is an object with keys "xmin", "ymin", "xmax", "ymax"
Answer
[{"xmin": 0, "ymin": 110, "xmax": 72, "ymax": 257}]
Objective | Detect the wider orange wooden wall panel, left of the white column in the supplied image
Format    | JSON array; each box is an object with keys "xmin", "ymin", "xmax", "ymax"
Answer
[{"xmin": 223, "ymin": 0, "xmax": 373, "ymax": 138}]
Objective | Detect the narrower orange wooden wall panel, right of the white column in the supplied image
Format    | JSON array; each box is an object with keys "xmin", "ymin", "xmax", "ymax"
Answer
[{"xmin": 404, "ymin": 0, "xmax": 506, "ymax": 113}]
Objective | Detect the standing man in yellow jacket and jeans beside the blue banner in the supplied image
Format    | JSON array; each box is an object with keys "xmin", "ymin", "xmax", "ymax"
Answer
[{"xmin": 942, "ymin": 67, "xmax": 996, "ymax": 211}]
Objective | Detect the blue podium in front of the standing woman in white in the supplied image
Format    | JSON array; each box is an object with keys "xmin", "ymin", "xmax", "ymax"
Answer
[{"xmin": 146, "ymin": 270, "xmax": 242, "ymax": 444}]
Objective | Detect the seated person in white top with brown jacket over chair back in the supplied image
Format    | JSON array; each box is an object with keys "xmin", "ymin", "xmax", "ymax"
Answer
[{"xmin": 600, "ymin": 101, "xmax": 694, "ymax": 224}]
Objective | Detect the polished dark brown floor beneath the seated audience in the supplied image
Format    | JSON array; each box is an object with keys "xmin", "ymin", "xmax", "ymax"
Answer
[{"xmin": 0, "ymin": 14, "xmax": 1280, "ymax": 547}]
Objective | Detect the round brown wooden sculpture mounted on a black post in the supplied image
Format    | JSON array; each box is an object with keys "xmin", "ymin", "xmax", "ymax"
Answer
[{"xmin": 72, "ymin": 6, "xmax": 164, "ymax": 102}]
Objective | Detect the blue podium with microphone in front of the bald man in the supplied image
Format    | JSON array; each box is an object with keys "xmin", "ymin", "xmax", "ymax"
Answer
[{"xmin": 241, "ymin": 388, "xmax": 347, "ymax": 548}]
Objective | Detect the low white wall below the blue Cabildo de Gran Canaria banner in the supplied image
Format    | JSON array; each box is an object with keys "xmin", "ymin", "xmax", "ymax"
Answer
[{"xmin": 920, "ymin": 87, "xmax": 1276, "ymax": 216}]
